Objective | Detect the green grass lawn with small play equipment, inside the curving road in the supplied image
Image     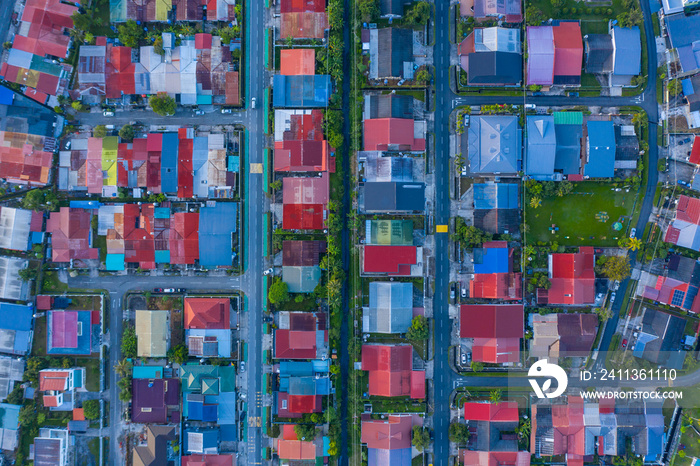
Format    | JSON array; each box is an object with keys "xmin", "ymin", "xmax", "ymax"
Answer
[{"xmin": 525, "ymin": 181, "xmax": 636, "ymax": 246}]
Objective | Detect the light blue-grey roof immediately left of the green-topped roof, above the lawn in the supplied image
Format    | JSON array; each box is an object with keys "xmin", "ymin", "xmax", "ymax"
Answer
[{"xmin": 525, "ymin": 115, "xmax": 557, "ymax": 178}]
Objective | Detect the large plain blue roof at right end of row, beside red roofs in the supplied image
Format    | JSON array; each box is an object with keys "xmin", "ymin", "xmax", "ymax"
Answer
[{"xmin": 199, "ymin": 202, "xmax": 238, "ymax": 267}]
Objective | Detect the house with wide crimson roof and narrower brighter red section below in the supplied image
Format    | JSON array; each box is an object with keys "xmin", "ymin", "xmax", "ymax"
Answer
[{"xmin": 459, "ymin": 304, "xmax": 524, "ymax": 364}]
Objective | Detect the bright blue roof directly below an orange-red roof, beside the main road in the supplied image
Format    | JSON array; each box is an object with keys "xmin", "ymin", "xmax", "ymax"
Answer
[{"xmin": 272, "ymin": 74, "xmax": 331, "ymax": 108}]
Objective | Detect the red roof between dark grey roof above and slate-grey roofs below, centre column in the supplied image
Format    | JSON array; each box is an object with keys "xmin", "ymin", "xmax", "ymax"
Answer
[{"xmin": 364, "ymin": 118, "xmax": 425, "ymax": 151}]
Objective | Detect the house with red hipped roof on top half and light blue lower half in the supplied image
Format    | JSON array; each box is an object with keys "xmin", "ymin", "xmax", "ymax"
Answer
[{"xmin": 184, "ymin": 298, "xmax": 231, "ymax": 358}]
